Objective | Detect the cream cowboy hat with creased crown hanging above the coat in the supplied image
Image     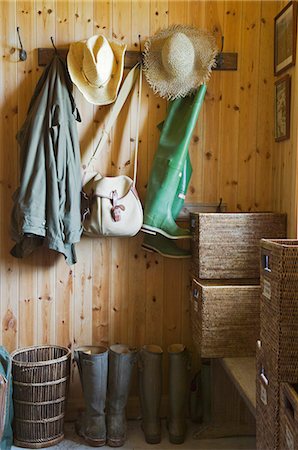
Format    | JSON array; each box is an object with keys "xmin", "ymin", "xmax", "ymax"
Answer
[{"xmin": 67, "ymin": 35, "xmax": 126, "ymax": 105}]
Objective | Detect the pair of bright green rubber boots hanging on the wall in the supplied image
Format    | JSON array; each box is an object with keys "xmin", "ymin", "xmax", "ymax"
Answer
[{"xmin": 142, "ymin": 84, "xmax": 206, "ymax": 258}]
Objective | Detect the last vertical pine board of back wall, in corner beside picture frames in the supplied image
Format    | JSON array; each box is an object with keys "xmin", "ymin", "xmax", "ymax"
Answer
[{"xmin": 254, "ymin": 1, "xmax": 277, "ymax": 211}]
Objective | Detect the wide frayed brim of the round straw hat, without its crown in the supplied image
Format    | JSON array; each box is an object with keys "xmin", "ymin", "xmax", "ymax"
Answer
[{"xmin": 143, "ymin": 25, "xmax": 218, "ymax": 100}]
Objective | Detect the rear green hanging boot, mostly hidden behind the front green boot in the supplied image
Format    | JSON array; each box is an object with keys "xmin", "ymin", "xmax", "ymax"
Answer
[{"xmin": 142, "ymin": 154, "xmax": 192, "ymax": 259}]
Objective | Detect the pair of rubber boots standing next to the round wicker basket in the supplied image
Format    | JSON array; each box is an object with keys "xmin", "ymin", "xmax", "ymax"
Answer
[{"xmin": 75, "ymin": 344, "xmax": 137, "ymax": 447}]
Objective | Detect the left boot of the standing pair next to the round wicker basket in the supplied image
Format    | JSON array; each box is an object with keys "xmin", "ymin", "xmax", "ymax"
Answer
[{"xmin": 74, "ymin": 346, "xmax": 108, "ymax": 447}]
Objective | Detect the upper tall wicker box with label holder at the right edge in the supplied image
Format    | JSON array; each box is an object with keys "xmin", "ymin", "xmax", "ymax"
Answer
[{"xmin": 260, "ymin": 239, "xmax": 298, "ymax": 383}]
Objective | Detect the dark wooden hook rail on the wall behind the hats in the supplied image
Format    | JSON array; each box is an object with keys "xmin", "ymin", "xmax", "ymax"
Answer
[{"xmin": 38, "ymin": 48, "xmax": 238, "ymax": 70}]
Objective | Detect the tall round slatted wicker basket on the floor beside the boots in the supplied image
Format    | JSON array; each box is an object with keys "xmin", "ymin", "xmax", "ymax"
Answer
[{"xmin": 11, "ymin": 345, "xmax": 70, "ymax": 448}]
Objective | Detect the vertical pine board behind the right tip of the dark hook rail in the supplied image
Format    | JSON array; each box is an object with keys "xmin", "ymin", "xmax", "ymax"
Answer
[{"xmin": 219, "ymin": 1, "xmax": 244, "ymax": 211}]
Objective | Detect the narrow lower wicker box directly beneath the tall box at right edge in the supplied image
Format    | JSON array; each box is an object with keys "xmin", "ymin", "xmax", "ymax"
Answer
[{"xmin": 256, "ymin": 342, "xmax": 284, "ymax": 450}]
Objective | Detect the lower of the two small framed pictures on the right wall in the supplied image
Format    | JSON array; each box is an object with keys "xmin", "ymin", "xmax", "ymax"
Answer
[{"xmin": 274, "ymin": 75, "xmax": 291, "ymax": 142}]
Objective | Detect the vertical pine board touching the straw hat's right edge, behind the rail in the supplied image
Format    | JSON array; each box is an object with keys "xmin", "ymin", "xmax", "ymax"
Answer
[{"xmin": 203, "ymin": 2, "xmax": 224, "ymax": 202}]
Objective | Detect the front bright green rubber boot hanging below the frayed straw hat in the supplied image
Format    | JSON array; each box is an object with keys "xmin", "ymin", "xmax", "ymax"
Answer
[{"xmin": 142, "ymin": 85, "xmax": 206, "ymax": 239}]
